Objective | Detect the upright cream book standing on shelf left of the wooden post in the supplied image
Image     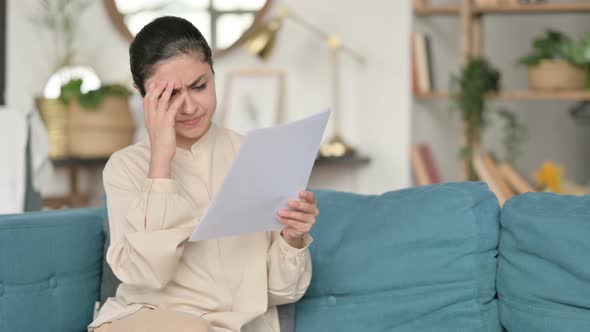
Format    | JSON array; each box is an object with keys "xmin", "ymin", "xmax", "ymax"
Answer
[{"xmin": 412, "ymin": 32, "xmax": 434, "ymax": 95}]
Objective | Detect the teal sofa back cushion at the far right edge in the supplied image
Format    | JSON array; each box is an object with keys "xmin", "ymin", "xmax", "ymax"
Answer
[{"xmin": 497, "ymin": 193, "xmax": 590, "ymax": 332}]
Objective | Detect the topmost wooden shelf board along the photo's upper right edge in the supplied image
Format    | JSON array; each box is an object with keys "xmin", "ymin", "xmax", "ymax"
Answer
[{"xmin": 414, "ymin": 2, "xmax": 590, "ymax": 16}]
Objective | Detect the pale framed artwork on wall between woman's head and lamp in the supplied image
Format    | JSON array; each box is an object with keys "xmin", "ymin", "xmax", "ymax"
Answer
[{"xmin": 220, "ymin": 69, "xmax": 285, "ymax": 134}]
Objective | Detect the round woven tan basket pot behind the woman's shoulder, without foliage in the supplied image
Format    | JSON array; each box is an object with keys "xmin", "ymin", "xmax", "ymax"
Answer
[{"xmin": 68, "ymin": 96, "xmax": 135, "ymax": 158}]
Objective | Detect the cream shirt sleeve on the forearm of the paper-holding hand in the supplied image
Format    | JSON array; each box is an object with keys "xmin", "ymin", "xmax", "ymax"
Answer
[{"xmin": 267, "ymin": 232, "xmax": 313, "ymax": 307}]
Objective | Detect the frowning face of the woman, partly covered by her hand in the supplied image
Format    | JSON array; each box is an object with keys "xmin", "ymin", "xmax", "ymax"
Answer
[{"xmin": 144, "ymin": 55, "xmax": 217, "ymax": 148}]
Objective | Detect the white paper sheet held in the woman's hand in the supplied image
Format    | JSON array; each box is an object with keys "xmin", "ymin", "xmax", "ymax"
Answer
[{"xmin": 190, "ymin": 111, "xmax": 330, "ymax": 241}]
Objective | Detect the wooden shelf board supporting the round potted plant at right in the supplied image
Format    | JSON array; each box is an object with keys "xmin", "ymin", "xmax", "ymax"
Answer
[{"xmin": 414, "ymin": 90, "xmax": 590, "ymax": 101}]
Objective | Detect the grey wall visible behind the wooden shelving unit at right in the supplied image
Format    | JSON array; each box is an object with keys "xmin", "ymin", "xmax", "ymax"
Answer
[{"xmin": 412, "ymin": 14, "xmax": 590, "ymax": 184}]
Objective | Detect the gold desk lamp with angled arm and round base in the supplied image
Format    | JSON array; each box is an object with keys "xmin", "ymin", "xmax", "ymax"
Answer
[{"xmin": 244, "ymin": 9, "xmax": 366, "ymax": 158}]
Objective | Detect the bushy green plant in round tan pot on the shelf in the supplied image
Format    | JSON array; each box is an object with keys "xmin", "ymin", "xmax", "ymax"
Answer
[{"xmin": 518, "ymin": 30, "xmax": 590, "ymax": 90}]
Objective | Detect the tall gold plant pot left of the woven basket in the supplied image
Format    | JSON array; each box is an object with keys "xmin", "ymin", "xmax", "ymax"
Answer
[{"xmin": 35, "ymin": 97, "xmax": 68, "ymax": 159}]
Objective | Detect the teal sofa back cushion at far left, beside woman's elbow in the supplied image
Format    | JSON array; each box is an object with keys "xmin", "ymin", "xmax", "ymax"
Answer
[{"xmin": 0, "ymin": 209, "xmax": 104, "ymax": 332}]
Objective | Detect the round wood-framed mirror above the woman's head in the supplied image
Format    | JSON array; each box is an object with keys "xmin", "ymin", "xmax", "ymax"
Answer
[{"xmin": 103, "ymin": 0, "xmax": 272, "ymax": 59}]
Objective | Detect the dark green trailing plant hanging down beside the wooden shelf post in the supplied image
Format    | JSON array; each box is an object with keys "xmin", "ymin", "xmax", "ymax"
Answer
[{"xmin": 451, "ymin": 58, "xmax": 526, "ymax": 180}]
